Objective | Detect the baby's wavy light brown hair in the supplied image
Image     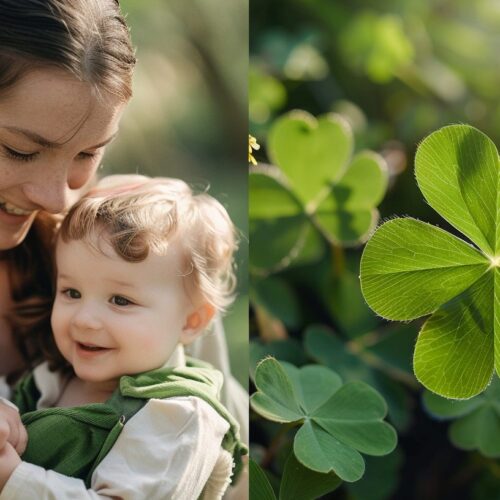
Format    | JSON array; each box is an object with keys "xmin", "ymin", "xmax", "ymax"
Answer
[{"xmin": 59, "ymin": 176, "xmax": 237, "ymax": 311}]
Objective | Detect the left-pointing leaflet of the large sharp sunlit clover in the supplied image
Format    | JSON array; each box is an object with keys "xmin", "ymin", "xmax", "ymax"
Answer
[{"xmin": 361, "ymin": 218, "xmax": 489, "ymax": 320}]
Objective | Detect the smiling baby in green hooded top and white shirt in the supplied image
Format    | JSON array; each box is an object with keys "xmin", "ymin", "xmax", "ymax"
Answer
[{"xmin": 0, "ymin": 176, "xmax": 247, "ymax": 500}]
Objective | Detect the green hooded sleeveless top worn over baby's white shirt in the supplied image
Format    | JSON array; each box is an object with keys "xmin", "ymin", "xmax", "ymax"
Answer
[{"xmin": 13, "ymin": 358, "xmax": 248, "ymax": 487}]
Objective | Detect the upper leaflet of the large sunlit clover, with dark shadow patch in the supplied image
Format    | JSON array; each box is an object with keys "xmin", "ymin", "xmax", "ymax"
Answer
[{"xmin": 415, "ymin": 125, "xmax": 500, "ymax": 255}]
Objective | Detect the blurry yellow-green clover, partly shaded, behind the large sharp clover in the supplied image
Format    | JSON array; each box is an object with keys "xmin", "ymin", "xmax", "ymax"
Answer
[{"xmin": 249, "ymin": 111, "xmax": 387, "ymax": 271}]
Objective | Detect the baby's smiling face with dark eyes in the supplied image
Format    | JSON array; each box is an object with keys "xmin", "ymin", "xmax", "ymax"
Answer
[{"xmin": 52, "ymin": 235, "xmax": 192, "ymax": 382}]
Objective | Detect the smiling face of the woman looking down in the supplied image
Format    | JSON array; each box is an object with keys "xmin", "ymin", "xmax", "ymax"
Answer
[{"xmin": 0, "ymin": 68, "xmax": 125, "ymax": 250}]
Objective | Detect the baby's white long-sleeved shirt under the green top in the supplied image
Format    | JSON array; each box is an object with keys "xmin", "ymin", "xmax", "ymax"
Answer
[{"xmin": 0, "ymin": 346, "xmax": 233, "ymax": 500}]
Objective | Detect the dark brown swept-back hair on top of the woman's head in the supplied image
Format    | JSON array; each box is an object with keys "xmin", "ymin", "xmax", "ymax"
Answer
[{"xmin": 0, "ymin": 0, "xmax": 135, "ymax": 101}]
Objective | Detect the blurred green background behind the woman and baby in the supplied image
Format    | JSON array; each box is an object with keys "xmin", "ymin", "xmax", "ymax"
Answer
[{"xmin": 101, "ymin": 0, "xmax": 248, "ymax": 386}]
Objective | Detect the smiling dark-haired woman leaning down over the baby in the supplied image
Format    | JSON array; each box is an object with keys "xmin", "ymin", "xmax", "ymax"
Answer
[{"xmin": 0, "ymin": 0, "xmax": 246, "ymax": 494}]
